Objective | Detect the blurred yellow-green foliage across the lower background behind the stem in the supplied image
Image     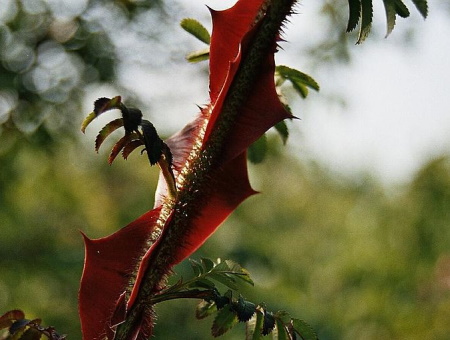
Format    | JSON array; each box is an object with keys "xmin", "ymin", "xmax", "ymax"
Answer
[{"xmin": 0, "ymin": 134, "xmax": 450, "ymax": 339}]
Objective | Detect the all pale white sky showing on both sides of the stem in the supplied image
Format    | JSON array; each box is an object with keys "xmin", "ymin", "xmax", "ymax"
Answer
[{"xmin": 113, "ymin": 0, "xmax": 450, "ymax": 183}]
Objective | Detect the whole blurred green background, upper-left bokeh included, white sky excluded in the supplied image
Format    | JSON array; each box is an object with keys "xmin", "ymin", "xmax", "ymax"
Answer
[{"xmin": 0, "ymin": 0, "xmax": 450, "ymax": 339}]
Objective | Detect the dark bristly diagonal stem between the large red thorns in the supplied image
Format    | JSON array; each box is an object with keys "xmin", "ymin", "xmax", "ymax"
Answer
[{"xmin": 115, "ymin": 0, "xmax": 295, "ymax": 340}]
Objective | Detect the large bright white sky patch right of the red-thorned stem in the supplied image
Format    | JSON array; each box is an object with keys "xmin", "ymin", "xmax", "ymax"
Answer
[{"xmin": 280, "ymin": 4, "xmax": 450, "ymax": 183}]
